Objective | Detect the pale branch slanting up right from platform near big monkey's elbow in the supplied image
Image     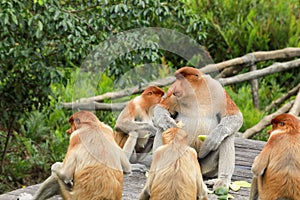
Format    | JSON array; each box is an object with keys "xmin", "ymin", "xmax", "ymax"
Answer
[{"xmin": 243, "ymin": 100, "xmax": 295, "ymax": 138}]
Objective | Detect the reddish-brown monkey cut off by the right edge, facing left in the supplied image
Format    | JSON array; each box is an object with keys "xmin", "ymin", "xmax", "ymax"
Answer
[{"xmin": 250, "ymin": 114, "xmax": 300, "ymax": 200}]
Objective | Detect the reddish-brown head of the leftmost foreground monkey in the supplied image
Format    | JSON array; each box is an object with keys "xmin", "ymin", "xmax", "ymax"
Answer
[{"xmin": 67, "ymin": 110, "xmax": 100, "ymax": 134}]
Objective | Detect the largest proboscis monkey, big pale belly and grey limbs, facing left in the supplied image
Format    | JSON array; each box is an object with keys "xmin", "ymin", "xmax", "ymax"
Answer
[{"xmin": 153, "ymin": 67, "xmax": 243, "ymax": 189}]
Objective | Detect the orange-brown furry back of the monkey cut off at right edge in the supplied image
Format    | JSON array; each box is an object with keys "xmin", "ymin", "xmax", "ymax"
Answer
[{"xmin": 258, "ymin": 134, "xmax": 300, "ymax": 200}]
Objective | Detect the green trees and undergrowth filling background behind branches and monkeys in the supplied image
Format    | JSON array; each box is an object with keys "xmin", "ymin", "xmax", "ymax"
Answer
[{"xmin": 0, "ymin": 0, "xmax": 300, "ymax": 193}]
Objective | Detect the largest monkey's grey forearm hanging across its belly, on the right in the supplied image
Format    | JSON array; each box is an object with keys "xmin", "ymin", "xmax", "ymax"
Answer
[{"xmin": 198, "ymin": 112, "xmax": 243, "ymax": 158}]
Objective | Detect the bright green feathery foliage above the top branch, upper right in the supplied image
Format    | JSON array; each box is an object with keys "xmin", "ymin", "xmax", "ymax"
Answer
[{"xmin": 186, "ymin": 0, "xmax": 300, "ymax": 62}]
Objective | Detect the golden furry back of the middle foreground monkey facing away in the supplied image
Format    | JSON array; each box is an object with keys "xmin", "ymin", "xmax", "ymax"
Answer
[{"xmin": 150, "ymin": 149, "xmax": 197, "ymax": 200}]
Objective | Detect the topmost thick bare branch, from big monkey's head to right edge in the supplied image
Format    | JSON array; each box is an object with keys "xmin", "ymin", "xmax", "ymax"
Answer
[{"xmin": 201, "ymin": 48, "xmax": 300, "ymax": 73}]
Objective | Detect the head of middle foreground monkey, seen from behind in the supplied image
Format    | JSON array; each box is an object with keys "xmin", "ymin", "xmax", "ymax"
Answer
[{"xmin": 162, "ymin": 127, "xmax": 187, "ymax": 144}]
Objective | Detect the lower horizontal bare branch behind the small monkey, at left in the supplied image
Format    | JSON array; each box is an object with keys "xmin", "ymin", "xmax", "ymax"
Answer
[{"xmin": 62, "ymin": 102, "xmax": 128, "ymax": 111}]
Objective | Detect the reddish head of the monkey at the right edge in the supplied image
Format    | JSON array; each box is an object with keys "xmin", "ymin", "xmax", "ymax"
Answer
[{"xmin": 268, "ymin": 114, "xmax": 300, "ymax": 134}]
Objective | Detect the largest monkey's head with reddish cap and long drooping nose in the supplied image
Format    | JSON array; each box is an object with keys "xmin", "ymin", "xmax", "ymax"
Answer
[{"xmin": 167, "ymin": 67, "xmax": 203, "ymax": 98}]
